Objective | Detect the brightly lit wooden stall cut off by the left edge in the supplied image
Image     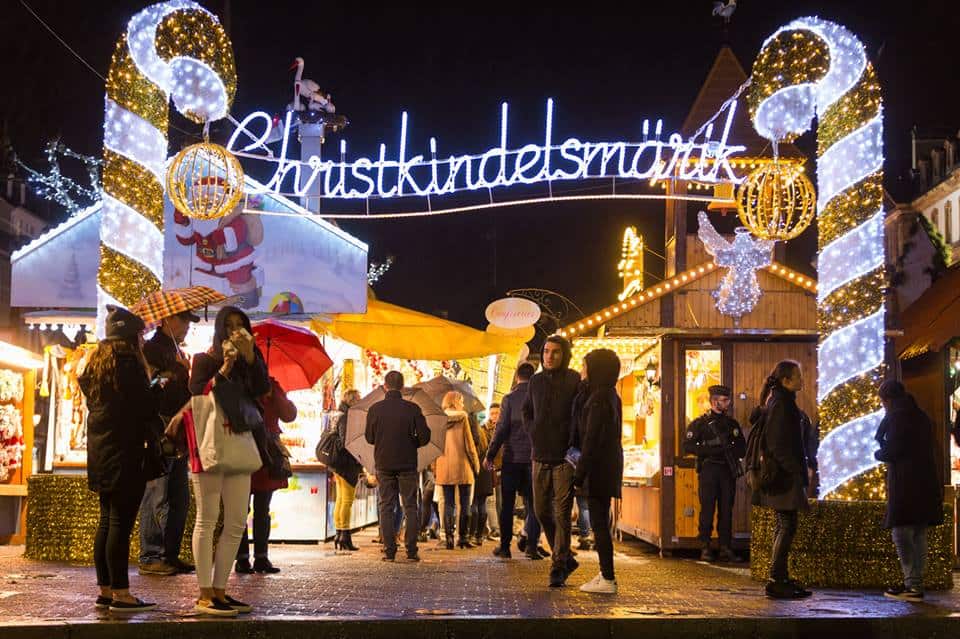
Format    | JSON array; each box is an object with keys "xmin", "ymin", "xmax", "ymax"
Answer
[{"xmin": 0, "ymin": 342, "xmax": 43, "ymax": 545}]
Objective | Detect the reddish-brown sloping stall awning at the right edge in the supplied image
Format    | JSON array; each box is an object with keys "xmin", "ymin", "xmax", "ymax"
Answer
[{"xmin": 896, "ymin": 266, "xmax": 960, "ymax": 359}]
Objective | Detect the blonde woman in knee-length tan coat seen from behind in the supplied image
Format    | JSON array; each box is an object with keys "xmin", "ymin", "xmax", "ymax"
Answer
[{"xmin": 436, "ymin": 391, "xmax": 480, "ymax": 550}]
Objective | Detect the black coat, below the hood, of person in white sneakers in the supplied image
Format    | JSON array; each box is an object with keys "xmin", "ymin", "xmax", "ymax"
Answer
[{"xmin": 572, "ymin": 387, "xmax": 623, "ymax": 498}]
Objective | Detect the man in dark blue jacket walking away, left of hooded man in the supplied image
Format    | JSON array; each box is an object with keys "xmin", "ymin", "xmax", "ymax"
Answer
[{"xmin": 483, "ymin": 363, "xmax": 542, "ymax": 560}]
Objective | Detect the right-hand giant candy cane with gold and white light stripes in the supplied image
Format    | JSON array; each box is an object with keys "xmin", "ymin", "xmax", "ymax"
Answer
[{"xmin": 748, "ymin": 18, "xmax": 884, "ymax": 499}]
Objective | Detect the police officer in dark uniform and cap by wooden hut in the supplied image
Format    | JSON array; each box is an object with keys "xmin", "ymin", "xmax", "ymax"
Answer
[{"xmin": 683, "ymin": 386, "xmax": 747, "ymax": 563}]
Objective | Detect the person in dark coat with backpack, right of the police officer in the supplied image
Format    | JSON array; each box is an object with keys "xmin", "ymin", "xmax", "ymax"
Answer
[{"xmin": 746, "ymin": 360, "xmax": 813, "ymax": 599}]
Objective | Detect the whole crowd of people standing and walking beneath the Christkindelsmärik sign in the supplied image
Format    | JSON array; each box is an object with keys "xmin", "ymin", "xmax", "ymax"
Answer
[{"xmin": 79, "ymin": 307, "xmax": 942, "ymax": 616}]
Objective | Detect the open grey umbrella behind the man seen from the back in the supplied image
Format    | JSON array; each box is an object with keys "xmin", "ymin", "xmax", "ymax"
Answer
[{"xmin": 345, "ymin": 387, "xmax": 447, "ymax": 472}]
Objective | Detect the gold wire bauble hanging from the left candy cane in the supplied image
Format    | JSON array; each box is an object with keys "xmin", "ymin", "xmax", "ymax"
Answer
[{"xmin": 167, "ymin": 142, "xmax": 243, "ymax": 220}]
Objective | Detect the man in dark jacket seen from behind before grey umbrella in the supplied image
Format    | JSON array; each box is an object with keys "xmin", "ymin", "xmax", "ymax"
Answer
[{"xmin": 365, "ymin": 371, "xmax": 430, "ymax": 561}]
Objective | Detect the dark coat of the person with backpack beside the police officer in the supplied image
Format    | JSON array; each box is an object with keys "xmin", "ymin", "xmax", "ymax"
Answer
[{"xmin": 753, "ymin": 386, "xmax": 809, "ymax": 510}]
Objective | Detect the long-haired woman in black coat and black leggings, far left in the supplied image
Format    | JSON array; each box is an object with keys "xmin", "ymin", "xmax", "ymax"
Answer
[{"xmin": 77, "ymin": 306, "xmax": 163, "ymax": 612}]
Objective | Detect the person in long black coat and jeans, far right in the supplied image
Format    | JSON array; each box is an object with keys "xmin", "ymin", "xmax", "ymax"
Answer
[{"xmin": 874, "ymin": 380, "xmax": 943, "ymax": 600}]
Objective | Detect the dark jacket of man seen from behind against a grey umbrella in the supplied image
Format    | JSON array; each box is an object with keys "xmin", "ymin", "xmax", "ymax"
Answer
[{"xmin": 364, "ymin": 391, "xmax": 430, "ymax": 473}]
